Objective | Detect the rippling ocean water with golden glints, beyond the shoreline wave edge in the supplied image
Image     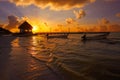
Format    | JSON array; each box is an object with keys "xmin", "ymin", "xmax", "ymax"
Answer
[{"xmin": 2, "ymin": 33, "xmax": 120, "ymax": 80}]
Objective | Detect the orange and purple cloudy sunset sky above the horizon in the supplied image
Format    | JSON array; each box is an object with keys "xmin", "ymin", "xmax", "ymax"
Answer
[{"xmin": 0, "ymin": 0, "xmax": 120, "ymax": 32}]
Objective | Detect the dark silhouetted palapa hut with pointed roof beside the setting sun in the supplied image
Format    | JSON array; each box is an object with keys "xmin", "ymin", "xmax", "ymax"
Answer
[{"xmin": 18, "ymin": 21, "xmax": 33, "ymax": 33}]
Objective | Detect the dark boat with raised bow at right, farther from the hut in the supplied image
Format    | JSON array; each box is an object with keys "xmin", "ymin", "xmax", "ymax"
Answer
[{"xmin": 81, "ymin": 32, "xmax": 110, "ymax": 40}]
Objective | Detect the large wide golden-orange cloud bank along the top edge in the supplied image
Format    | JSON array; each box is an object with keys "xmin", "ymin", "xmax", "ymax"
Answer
[{"xmin": 10, "ymin": 0, "xmax": 95, "ymax": 10}]
